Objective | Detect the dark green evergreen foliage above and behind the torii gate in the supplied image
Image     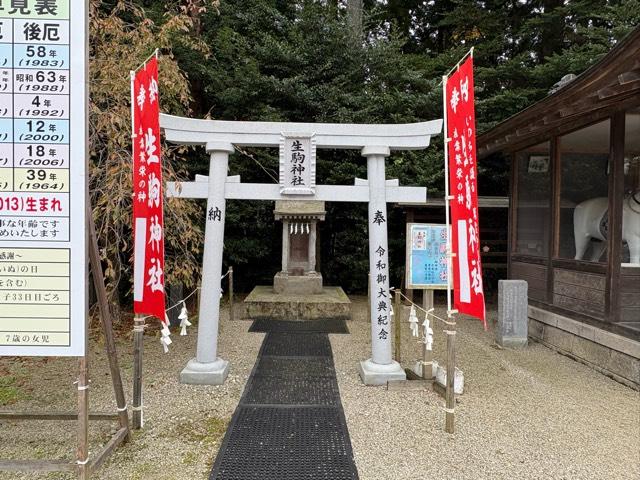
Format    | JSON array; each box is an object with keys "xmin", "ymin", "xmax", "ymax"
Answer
[{"xmin": 129, "ymin": 0, "xmax": 640, "ymax": 291}]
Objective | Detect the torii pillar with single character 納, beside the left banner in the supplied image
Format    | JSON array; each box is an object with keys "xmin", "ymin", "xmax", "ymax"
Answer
[{"xmin": 180, "ymin": 143, "xmax": 233, "ymax": 385}]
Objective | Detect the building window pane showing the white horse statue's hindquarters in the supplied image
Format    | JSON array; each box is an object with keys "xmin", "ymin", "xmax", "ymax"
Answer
[{"xmin": 558, "ymin": 120, "xmax": 610, "ymax": 263}]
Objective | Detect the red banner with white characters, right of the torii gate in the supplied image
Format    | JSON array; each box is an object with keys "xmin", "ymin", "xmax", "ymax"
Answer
[{"xmin": 445, "ymin": 56, "xmax": 486, "ymax": 328}]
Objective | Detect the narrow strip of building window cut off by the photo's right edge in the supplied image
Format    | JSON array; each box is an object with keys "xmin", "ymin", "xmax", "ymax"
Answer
[{"xmin": 621, "ymin": 109, "xmax": 640, "ymax": 267}]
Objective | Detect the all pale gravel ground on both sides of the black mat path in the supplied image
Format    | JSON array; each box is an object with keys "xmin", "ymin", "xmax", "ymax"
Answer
[{"xmin": 0, "ymin": 298, "xmax": 640, "ymax": 480}]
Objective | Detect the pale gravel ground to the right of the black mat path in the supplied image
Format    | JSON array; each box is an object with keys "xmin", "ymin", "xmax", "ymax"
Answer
[{"xmin": 330, "ymin": 296, "xmax": 640, "ymax": 480}]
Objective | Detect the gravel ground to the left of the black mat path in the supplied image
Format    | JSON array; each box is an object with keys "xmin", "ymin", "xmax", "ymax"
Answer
[{"xmin": 0, "ymin": 310, "xmax": 264, "ymax": 480}]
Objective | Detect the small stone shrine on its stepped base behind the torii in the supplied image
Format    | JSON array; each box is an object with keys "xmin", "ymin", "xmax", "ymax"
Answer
[{"xmin": 244, "ymin": 200, "xmax": 351, "ymax": 320}]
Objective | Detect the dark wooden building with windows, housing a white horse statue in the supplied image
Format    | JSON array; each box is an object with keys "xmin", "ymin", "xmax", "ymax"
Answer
[{"xmin": 477, "ymin": 28, "xmax": 640, "ymax": 387}]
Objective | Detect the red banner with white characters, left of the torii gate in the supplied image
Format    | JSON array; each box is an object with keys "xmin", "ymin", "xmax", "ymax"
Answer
[{"xmin": 131, "ymin": 58, "xmax": 165, "ymax": 323}]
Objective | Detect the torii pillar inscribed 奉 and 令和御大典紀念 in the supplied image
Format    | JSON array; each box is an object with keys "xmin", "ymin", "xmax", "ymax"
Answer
[{"xmin": 360, "ymin": 147, "xmax": 406, "ymax": 385}]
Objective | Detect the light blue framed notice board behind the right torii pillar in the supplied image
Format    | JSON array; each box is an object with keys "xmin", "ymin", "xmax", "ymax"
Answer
[{"xmin": 405, "ymin": 223, "xmax": 447, "ymax": 290}]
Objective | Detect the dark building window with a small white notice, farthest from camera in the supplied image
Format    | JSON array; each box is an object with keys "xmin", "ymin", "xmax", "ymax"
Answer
[{"xmin": 515, "ymin": 142, "xmax": 551, "ymax": 256}]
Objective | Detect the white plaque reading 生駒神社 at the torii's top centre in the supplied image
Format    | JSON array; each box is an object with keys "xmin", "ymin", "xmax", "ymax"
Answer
[{"xmin": 280, "ymin": 133, "xmax": 316, "ymax": 195}]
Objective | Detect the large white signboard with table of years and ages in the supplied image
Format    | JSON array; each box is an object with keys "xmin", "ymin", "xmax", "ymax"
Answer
[{"xmin": 0, "ymin": 0, "xmax": 87, "ymax": 356}]
